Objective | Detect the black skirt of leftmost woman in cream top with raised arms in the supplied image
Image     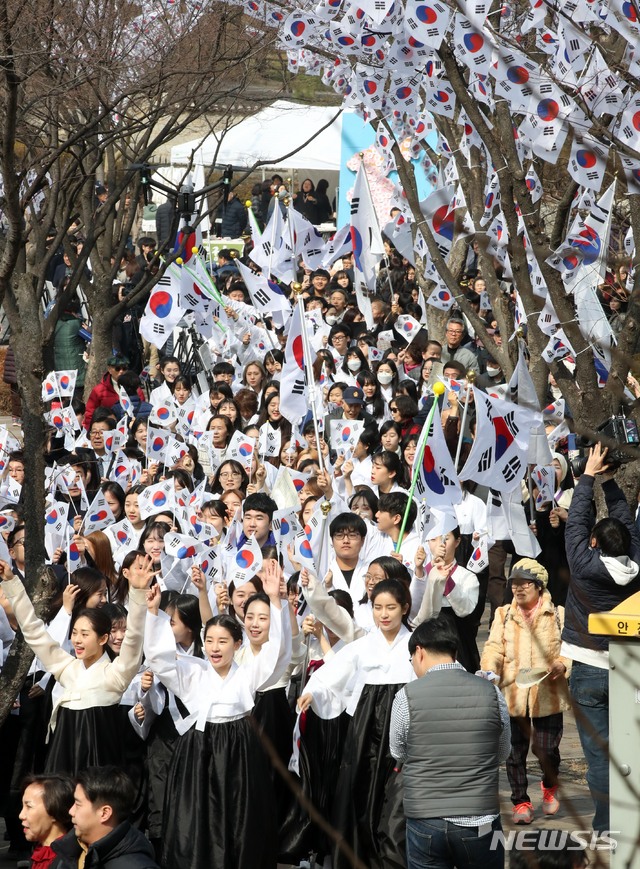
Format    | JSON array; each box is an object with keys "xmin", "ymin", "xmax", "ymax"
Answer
[{"xmin": 45, "ymin": 704, "xmax": 125, "ymax": 776}]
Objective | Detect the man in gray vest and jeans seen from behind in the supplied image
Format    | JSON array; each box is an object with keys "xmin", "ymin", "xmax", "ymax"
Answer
[{"xmin": 389, "ymin": 617, "xmax": 511, "ymax": 869}]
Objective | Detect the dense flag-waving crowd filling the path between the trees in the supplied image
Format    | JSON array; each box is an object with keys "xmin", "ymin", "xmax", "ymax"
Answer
[{"xmin": 0, "ymin": 210, "xmax": 640, "ymax": 869}]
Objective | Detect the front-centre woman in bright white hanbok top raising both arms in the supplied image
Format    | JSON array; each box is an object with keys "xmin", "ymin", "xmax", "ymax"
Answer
[{"xmin": 145, "ymin": 570, "xmax": 291, "ymax": 869}]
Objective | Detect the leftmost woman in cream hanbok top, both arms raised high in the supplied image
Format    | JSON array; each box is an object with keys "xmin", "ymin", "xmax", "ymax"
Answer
[{"xmin": 0, "ymin": 555, "xmax": 153, "ymax": 773}]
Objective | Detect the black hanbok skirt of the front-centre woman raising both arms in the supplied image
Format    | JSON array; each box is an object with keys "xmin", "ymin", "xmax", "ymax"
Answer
[{"xmin": 162, "ymin": 716, "xmax": 277, "ymax": 869}]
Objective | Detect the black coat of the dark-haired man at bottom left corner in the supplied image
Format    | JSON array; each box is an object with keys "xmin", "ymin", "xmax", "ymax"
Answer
[{"xmin": 51, "ymin": 821, "xmax": 158, "ymax": 869}]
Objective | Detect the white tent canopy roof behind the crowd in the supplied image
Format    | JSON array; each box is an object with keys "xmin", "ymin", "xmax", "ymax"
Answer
[{"xmin": 171, "ymin": 100, "xmax": 342, "ymax": 172}]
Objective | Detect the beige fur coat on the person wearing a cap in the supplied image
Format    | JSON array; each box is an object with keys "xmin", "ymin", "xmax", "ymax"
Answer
[{"xmin": 480, "ymin": 590, "xmax": 571, "ymax": 718}]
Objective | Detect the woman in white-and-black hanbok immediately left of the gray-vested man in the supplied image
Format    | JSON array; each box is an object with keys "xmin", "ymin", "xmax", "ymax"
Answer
[{"xmin": 298, "ymin": 579, "xmax": 415, "ymax": 869}]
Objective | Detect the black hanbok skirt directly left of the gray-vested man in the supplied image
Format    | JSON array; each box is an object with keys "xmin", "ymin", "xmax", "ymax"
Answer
[{"xmin": 332, "ymin": 684, "xmax": 406, "ymax": 869}]
